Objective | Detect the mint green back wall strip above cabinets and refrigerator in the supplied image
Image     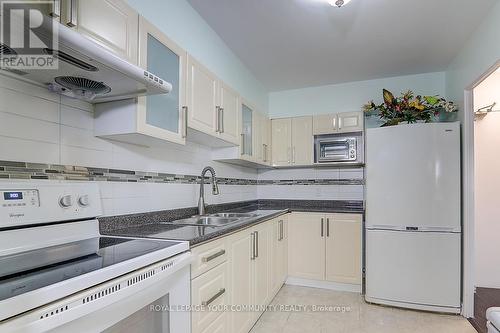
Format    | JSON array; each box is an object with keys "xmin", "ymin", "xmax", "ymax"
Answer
[{"xmin": 269, "ymin": 72, "xmax": 445, "ymax": 118}]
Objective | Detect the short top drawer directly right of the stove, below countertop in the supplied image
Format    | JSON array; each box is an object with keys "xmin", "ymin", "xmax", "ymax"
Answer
[{"xmin": 191, "ymin": 239, "xmax": 227, "ymax": 279}]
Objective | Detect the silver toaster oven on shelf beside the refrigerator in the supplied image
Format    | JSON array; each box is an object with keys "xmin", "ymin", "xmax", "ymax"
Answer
[{"xmin": 315, "ymin": 137, "xmax": 358, "ymax": 163}]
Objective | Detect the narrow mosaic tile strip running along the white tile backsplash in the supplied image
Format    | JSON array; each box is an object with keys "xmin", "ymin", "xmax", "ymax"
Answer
[{"xmin": 0, "ymin": 161, "xmax": 364, "ymax": 185}]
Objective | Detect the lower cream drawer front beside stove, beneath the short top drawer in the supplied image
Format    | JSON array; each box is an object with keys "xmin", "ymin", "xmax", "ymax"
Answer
[{"xmin": 191, "ymin": 263, "xmax": 228, "ymax": 333}]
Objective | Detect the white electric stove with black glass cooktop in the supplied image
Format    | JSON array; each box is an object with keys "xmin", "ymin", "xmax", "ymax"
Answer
[{"xmin": 0, "ymin": 182, "xmax": 191, "ymax": 333}]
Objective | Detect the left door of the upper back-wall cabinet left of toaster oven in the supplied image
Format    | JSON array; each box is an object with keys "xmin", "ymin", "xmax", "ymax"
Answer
[{"xmin": 271, "ymin": 118, "xmax": 292, "ymax": 166}]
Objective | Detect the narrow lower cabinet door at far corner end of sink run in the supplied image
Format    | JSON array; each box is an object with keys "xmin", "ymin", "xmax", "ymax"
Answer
[{"xmin": 270, "ymin": 215, "xmax": 288, "ymax": 298}]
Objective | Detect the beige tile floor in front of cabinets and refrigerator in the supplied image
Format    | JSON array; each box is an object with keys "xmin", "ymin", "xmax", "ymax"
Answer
[{"xmin": 251, "ymin": 286, "xmax": 476, "ymax": 333}]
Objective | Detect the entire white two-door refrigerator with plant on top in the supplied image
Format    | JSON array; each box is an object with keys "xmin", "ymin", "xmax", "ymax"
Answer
[{"xmin": 365, "ymin": 123, "xmax": 461, "ymax": 313}]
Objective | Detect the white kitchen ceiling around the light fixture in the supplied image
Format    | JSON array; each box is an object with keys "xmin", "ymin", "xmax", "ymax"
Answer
[{"xmin": 188, "ymin": 0, "xmax": 498, "ymax": 91}]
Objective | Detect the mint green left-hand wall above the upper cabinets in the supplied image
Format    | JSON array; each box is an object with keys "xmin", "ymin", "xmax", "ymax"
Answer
[{"xmin": 127, "ymin": 0, "xmax": 268, "ymax": 112}]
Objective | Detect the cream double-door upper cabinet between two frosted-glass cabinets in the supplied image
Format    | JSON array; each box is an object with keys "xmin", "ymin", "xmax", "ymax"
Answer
[{"xmin": 186, "ymin": 56, "xmax": 240, "ymax": 147}]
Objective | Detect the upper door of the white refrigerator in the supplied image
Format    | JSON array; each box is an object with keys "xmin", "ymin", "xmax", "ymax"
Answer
[{"xmin": 366, "ymin": 123, "xmax": 461, "ymax": 231}]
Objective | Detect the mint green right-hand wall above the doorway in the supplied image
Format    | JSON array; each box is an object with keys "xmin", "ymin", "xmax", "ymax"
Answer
[{"xmin": 446, "ymin": 1, "xmax": 500, "ymax": 118}]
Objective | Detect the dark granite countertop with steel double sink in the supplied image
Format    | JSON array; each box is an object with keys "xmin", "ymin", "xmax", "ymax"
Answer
[{"xmin": 99, "ymin": 200, "xmax": 364, "ymax": 247}]
